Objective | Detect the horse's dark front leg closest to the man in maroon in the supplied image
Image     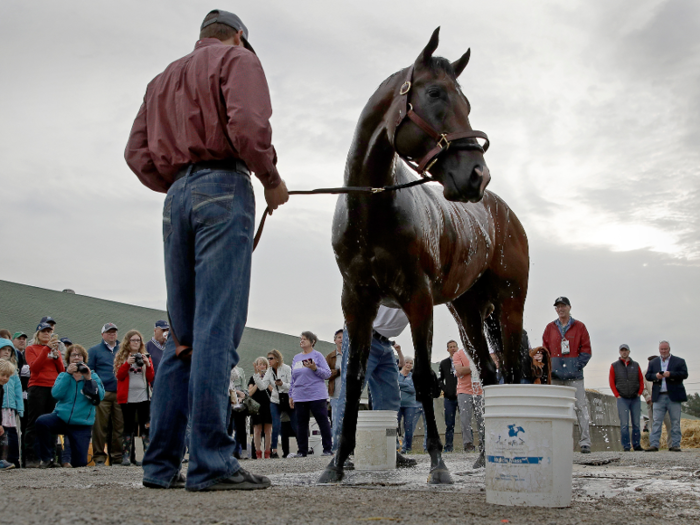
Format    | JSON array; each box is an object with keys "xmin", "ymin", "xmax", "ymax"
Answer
[{"xmin": 318, "ymin": 287, "xmax": 379, "ymax": 483}]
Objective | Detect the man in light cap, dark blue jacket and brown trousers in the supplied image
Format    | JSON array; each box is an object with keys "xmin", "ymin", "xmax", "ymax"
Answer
[{"xmin": 88, "ymin": 323, "xmax": 124, "ymax": 467}]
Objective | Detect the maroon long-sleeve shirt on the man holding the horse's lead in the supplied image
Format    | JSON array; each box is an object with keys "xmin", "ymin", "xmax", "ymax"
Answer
[{"xmin": 124, "ymin": 38, "xmax": 281, "ymax": 193}]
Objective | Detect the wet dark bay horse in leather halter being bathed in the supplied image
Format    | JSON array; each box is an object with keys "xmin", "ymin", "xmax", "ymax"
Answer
[{"xmin": 319, "ymin": 28, "xmax": 529, "ymax": 483}]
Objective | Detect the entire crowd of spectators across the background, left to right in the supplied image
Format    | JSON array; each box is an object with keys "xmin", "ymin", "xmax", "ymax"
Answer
[{"xmin": 0, "ymin": 298, "xmax": 687, "ymax": 470}]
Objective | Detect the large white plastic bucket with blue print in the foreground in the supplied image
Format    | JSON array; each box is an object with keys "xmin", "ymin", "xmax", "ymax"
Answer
[{"xmin": 484, "ymin": 385, "xmax": 576, "ymax": 507}]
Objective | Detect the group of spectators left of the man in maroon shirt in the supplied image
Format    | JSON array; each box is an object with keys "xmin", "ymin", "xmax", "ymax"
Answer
[{"xmin": 0, "ymin": 317, "xmax": 160, "ymax": 470}]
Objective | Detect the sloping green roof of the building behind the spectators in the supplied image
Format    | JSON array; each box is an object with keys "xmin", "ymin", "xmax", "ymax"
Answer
[{"xmin": 0, "ymin": 280, "xmax": 335, "ymax": 368}]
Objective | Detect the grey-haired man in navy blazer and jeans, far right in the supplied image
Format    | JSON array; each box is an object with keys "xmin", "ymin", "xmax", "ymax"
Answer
[{"xmin": 646, "ymin": 341, "xmax": 688, "ymax": 452}]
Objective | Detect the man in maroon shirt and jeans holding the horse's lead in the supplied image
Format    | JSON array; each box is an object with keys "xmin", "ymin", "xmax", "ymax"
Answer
[{"xmin": 125, "ymin": 10, "xmax": 289, "ymax": 491}]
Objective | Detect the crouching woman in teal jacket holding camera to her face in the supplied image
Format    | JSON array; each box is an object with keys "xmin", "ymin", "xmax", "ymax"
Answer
[{"xmin": 35, "ymin": 345, "xmax": 105, "ymax": 468}]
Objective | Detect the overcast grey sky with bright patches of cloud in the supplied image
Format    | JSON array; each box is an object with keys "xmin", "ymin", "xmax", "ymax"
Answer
[{"xmin": 0, "ymin": 0, "xmax": 700, "ymax": 391}]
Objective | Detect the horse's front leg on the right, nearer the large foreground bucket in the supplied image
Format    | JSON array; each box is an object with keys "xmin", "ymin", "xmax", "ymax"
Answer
[{"xmin": 406, "ymin": 294, "xmax": 454, "ymax": 484}]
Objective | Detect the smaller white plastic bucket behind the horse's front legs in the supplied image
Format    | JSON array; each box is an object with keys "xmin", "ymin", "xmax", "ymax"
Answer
[{"xmin": 355, "ymin": 410, "xmax": 397, "ymax": 470}]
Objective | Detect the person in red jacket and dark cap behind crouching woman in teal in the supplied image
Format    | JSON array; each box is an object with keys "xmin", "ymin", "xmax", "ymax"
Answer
[{"xmin": 24, "ymin": 323, "xmax": 66, "ymax": 466}]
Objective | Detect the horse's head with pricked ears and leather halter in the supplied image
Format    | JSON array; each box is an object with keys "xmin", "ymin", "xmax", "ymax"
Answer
[{"xmin": 387, "ymin": 27, "xmax": 491, "ymax": 202}]
